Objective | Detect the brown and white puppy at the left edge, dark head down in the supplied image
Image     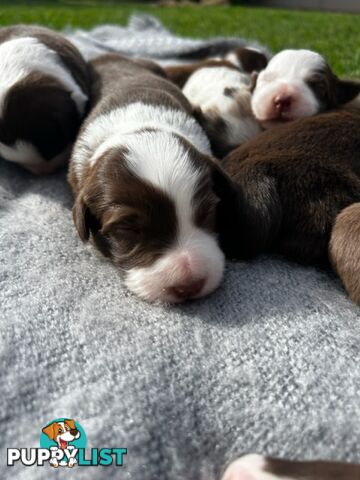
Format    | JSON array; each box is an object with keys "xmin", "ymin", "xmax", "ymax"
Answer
[{"xmin": 0, "ymin": 25, "xmax": 89, "ymax": 174}]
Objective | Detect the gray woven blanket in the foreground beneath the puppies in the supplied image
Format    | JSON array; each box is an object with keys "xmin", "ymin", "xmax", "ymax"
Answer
[{"xmin": 0, "ymin": 15, "xmax": 360, "ymax": 480}]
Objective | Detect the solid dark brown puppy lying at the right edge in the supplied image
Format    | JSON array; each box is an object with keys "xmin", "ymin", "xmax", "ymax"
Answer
[{"xmin": 219, "ymin": 110, "xmax": 360, "ymax": 302}]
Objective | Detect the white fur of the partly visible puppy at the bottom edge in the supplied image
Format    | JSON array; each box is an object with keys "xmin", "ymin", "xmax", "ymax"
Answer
[{"xmin": 221, "ymin": 454, "xmax": 295, "ymax": 480}]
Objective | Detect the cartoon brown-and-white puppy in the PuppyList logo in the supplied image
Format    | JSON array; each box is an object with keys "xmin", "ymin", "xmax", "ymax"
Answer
[{"xmin": 42, "ymin": 419, "xmax": 80, "ymax": 468}]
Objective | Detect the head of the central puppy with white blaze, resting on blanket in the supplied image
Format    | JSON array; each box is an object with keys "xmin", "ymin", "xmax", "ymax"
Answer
[{"xmin": 73, "ymin": 130, "xmax": 233, "ymax": 303}]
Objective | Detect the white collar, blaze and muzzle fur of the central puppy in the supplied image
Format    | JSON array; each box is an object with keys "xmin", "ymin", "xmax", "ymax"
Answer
[{"xmin": 73, "ymin": 103, "xmax": 224, "ymax": 302}]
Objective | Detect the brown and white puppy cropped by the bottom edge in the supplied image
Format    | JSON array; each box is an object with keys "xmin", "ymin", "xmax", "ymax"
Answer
[{"xmin": 221, "ymin": 454, "xmax": 360, "ymax": 480}]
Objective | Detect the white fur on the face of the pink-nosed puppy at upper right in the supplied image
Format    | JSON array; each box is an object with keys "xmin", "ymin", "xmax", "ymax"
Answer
[{"xmin": 252, "ymin": 50, "xmax": 325, "ymax": 126}]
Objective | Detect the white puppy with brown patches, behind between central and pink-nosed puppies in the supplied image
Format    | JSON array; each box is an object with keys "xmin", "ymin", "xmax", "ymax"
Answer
[{"xmin": 166, "ymin": 48, "xmax": 267, "ymax": 158}]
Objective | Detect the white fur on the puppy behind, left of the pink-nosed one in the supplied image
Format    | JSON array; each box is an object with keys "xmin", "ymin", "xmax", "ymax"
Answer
[{"xmin": 183, "ymin": 67, "xmax": 261, "ymax": 146}]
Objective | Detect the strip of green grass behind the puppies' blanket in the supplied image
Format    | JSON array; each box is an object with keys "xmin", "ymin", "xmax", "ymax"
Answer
[{"xmin": 0, "ymin": 0, "xmax": 360, "ymax": 78}]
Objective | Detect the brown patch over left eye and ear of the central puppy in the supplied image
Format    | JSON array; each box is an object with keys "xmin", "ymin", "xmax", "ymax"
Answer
[{"xmin": 73, "ymin": 145, "xmax": 177, "ymax": 269}]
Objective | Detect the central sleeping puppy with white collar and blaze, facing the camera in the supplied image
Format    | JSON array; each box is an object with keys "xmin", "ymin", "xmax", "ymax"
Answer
[{"xmin": 69, "ymin": 55, "xmax": 233, "ymax": 303}]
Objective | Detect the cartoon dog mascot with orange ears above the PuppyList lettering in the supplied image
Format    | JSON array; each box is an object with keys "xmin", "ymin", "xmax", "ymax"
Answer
[{"xmin": 42, "ymin": 418, "xmax": 81, "ymax": 468}]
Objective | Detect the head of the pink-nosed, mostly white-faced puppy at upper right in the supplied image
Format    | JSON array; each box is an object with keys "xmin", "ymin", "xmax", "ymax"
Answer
[{"xmin": 252, "ymin": 50, "xmax": 360, "ymax": 128}]
